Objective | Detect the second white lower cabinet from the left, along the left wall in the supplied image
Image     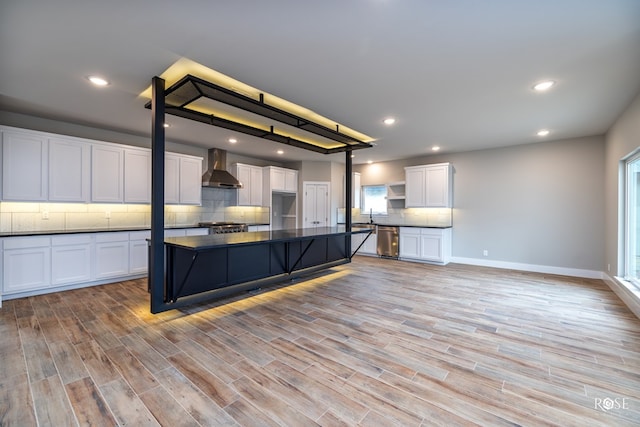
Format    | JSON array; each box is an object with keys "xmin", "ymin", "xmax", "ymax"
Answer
[{"xmin": 51, "ymin": 234, "xmax": 92, "ymax": 286}]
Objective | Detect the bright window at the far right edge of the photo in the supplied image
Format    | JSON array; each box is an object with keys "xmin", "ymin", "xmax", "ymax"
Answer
[{"xmin": 624, "ymin": 153, "xmax": 640, "ymax": 287}]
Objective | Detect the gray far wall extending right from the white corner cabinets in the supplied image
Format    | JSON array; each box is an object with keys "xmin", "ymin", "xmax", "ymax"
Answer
[{"xmin": 356, "ymin": 137, "xmax": 604, "ymax": 271}]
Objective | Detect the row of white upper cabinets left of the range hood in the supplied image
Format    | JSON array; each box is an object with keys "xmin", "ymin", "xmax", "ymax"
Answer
[{"xmin": 0, "ymin": 126, "xmax": 202, "ymax": 205}]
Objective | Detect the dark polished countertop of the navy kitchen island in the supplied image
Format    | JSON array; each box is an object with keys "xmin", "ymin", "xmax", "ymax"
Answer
[{"xmin": 164, "ymin": 226, "xmax": 371, "ymax": 250}]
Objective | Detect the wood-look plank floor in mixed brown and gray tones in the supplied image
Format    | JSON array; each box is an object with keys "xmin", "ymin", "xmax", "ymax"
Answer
[{"xmin": 0, "ymin": 257, "xmax": 640, "ymax": 427}]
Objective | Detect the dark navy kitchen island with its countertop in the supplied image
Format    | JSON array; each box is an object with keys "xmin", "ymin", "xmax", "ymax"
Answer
[{"xmin": 151, "ymin": 226, "xmax": 371, "ymax": 313}]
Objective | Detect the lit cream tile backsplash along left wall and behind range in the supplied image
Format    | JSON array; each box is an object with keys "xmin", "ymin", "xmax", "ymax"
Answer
[{"xmin": 0, "ymin": 188, "xmax": 269, "ymax": 233}]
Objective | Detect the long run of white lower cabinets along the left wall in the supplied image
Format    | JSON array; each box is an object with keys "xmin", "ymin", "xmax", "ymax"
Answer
[{"xmin": 0, "ymin": 228, "xmax": 214, "ymax": 299}]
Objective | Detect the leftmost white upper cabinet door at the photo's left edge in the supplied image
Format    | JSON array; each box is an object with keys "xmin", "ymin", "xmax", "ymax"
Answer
[{"xmin": 2, "ymin": 131, "xmax": 48, "ymax": 201}]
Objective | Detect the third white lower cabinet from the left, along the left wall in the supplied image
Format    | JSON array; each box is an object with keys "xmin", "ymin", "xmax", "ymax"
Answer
[{"xmin": 95, "ymin": 232, "xmax": 129, "ymax": 279}]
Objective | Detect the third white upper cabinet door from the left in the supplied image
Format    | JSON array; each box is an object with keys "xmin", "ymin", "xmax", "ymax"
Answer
[{"xmin": 91, "ymin": 145, "xmax": 124, "ymax": 203}]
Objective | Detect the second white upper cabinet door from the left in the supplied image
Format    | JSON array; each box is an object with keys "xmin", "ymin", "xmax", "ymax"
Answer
[{"xmin": 49, "ymin": 138, "xmax": 91, "ymax": 202}]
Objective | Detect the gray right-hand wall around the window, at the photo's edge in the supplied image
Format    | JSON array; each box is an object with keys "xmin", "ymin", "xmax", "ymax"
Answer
[{"xmin": 603, "ymin": 94, "xmax": 640, "ymax": 275}]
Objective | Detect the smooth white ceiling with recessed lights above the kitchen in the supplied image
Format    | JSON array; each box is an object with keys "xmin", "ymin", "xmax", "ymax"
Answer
[{"xmin": 0, "ymin": 0, "xmax": 640, "ymax": 163}]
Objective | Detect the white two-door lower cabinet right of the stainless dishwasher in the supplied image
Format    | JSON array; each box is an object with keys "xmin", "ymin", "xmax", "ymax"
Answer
[{"xmin": 400, "ymin": 227, "xmax": 451, "ymax": 265}]
